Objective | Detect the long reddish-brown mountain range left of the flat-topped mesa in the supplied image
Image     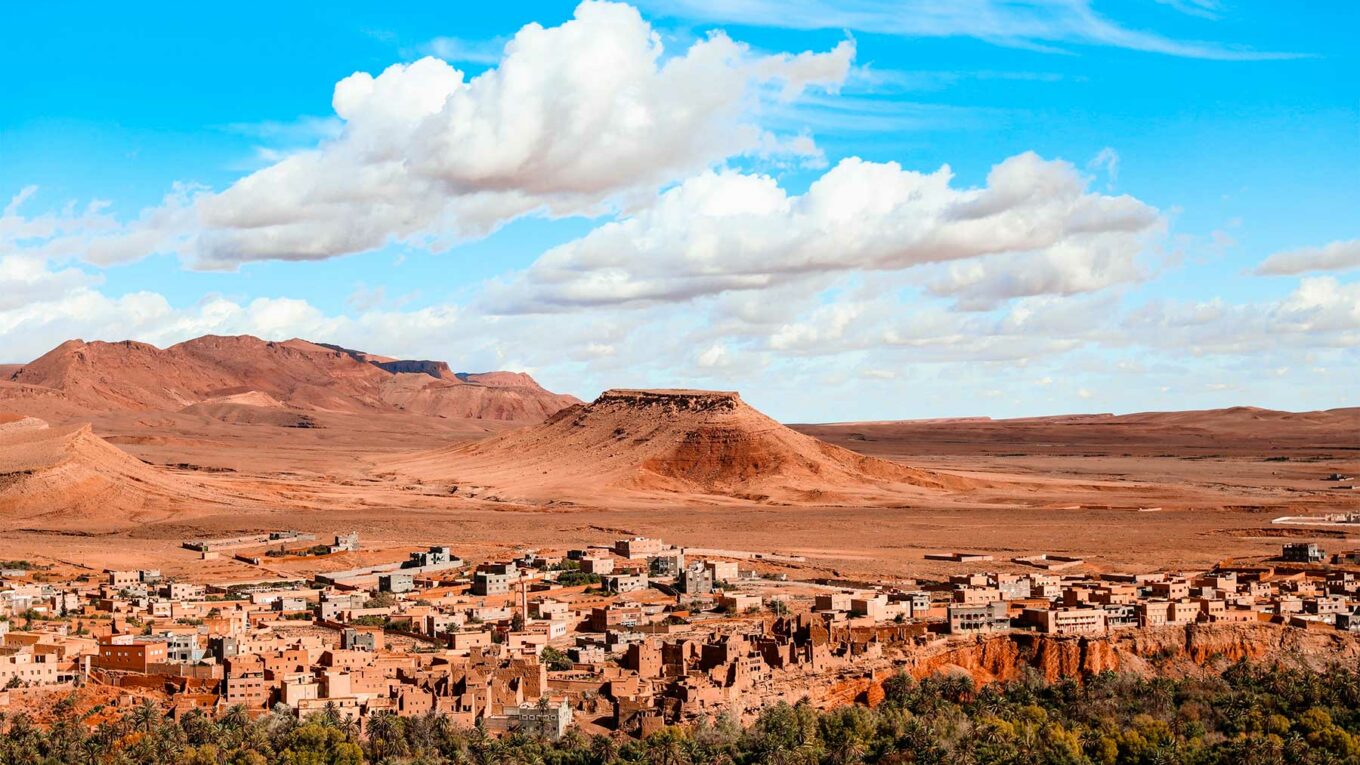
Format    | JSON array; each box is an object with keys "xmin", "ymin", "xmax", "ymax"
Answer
[{"xmin": 0, "ymin": 335, "xmax": 581, "ymax": 422}]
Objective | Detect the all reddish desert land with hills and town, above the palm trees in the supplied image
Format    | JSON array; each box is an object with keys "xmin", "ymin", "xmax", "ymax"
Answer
[{"xmin": 0, "ymin": 336, "xmax": 1360, "ymax": 736}]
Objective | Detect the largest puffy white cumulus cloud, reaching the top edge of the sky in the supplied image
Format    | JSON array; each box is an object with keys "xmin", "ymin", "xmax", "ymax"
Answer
[{"xmin": 52, "ymin": 0, "xmax": 854, "ymax": 268}]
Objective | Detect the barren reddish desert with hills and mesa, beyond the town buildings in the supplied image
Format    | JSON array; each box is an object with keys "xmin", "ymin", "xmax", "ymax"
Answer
[{"xmin": 0, "ymin": 332, "xmax": 1360, "ymax": 576}]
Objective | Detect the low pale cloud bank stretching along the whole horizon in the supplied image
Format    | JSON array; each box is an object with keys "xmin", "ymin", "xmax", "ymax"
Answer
[{"xmin": 0, "ymin": 253, "xmax": 1360, "ymax": 421}]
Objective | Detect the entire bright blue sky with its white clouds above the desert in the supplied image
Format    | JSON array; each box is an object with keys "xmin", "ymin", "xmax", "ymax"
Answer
[{"xmin": 0, "ymin": 0, "xmax": 1360, "ymax": 421}]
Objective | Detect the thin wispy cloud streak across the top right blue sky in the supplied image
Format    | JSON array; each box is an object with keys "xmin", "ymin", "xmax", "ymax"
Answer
[{"xmin": 645, "ymin": 0, "xmax": 1302, "ymax": 61}]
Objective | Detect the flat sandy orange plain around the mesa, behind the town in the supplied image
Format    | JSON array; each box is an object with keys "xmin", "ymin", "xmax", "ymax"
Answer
[{"xmin": 0, "ymin": 405, "xmax": 1360, "ymax": 580}]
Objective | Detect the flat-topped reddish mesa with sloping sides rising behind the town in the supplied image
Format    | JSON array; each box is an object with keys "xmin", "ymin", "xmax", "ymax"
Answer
[{"xmin": 392, "ymin": 389, "xmax": 974, "ymax": 504}]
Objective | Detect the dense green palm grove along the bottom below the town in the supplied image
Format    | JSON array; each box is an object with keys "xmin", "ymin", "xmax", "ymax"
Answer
[{"xmin": 0, "ymin": 664, "xmax": 1360, "ymax": 765}]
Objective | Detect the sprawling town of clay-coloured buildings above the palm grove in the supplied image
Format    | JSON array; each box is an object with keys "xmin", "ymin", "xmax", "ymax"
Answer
[{"xmin": 0, "ymin": 531, "xmax": 1360, "ymax": 739}]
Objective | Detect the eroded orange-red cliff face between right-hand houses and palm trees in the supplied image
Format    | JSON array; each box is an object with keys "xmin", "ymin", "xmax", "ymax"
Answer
[{"xmin": 848, "ymin": 622, "xmax": 1360, "ymax": 702}]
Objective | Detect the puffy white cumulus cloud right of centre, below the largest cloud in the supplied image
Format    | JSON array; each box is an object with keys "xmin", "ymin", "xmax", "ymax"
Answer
[{"xmin": 490, "ymin": 152, "xmax": 1161, "ymax": 313}]
